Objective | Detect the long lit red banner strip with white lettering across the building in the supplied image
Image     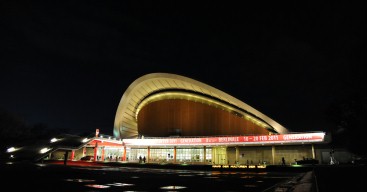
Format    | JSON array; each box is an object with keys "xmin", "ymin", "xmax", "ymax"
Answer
[{"xmin": 123, "ymin": 133, "xmax": 325, "ymax": 146}]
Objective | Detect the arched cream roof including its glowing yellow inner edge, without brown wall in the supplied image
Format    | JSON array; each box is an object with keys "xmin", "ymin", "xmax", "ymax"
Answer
[{"xmin": 114, "ymin": 73, "xmax": 288, "ymax": 138}]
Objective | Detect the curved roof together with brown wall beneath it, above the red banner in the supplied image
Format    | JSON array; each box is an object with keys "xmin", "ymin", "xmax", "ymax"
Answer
[{"xmin": 114, "ymin": 73, "xmax": 288, "ymax": 138}]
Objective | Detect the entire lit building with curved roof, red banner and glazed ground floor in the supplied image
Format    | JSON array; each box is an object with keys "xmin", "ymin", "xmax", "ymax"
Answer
[{"xmin": 114, "ymin": 73, "xmax": 325, "ymax": 164}]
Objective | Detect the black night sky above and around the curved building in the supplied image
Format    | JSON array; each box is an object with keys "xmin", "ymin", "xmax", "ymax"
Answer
[{"xmin": 0, "ymin": 1, "xmax": 366, "ymax": 135}]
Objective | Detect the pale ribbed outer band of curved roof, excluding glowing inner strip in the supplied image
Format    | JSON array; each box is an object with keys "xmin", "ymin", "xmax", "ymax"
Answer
[{"xmin": 113, "ymin": 73, "xmax": 288, "ymax": 138}]
